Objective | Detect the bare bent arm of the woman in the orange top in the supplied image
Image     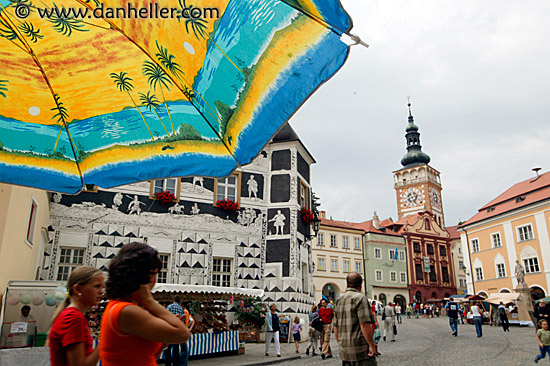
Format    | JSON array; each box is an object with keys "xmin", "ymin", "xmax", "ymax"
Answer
[{"xmin": 119, "ymin": 285, "xmax": 191, "ymax": 344}]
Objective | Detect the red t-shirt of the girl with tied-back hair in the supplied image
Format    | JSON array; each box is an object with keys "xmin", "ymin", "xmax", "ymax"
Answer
[{"xmin": 49, "ymin": 307, "xmax": 93, "ymax": 366}]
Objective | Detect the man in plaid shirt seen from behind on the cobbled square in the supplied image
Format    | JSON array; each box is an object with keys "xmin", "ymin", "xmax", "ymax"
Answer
[{"xmin": 334, "ymin": 272, "xmax": 376, "ymax": 366}]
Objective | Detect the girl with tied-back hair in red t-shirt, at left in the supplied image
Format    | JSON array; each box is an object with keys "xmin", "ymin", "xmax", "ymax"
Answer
[{"xmin": 48, "ymin": 266, "xmax": 105, "ymax": 366}]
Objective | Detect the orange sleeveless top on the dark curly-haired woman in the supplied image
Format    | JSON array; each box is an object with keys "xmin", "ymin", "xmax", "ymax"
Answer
[{"xmin": 99, "ymin": 300, "xmax": 162, "ymax": 366}]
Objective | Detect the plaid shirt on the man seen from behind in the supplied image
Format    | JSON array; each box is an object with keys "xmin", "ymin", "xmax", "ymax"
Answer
[{"xmin": 334, "ymin": 288, "xmax": 374, "ymax": 361}]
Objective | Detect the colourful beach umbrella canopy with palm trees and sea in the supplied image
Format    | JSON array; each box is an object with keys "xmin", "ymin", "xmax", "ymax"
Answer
[{"xmin": 0, "ymin": 0, "xmax": 351, "ymax": 193}]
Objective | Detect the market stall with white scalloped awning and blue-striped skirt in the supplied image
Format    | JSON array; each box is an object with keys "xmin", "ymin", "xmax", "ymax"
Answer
[{"xmin": 153, "ymin": 284, "xmax": 265, "ymax": 356}]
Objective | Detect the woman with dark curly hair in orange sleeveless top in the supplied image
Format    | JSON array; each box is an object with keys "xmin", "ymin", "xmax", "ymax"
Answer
[{"xmin": 99, "ymin": 242, "xmax": 191, "ymax": 366}]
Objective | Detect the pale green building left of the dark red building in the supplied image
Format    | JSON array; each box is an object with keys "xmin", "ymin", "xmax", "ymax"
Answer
[{"xmin": 357, "ymin": 213, "xmax": 410, "ymax": 307}]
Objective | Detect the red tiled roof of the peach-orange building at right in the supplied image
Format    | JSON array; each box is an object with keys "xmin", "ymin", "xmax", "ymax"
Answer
[{"xmin": 460, "ymin": 172, "xmax": 550, "ymax": 227}]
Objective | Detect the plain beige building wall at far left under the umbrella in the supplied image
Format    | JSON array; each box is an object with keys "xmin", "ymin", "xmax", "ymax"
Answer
[{"xmin": 0, "ymin": 184, "xmax": 49, "ymax": 304}]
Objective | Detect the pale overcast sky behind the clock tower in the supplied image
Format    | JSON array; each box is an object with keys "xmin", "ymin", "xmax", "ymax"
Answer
[{"xmin": 291, "ymin": 0, "xmax": 550, "ymax": 226}]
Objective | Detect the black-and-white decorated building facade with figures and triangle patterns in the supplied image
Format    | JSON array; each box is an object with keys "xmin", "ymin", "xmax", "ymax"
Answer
[{"xmin": 40, "ymin": 124, "xmax": 315, "ymax": 314}]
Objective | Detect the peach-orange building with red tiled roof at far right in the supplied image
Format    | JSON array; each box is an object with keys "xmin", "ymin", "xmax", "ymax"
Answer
[{"xmin": 458, "ymin": 172, "xmax": 550, "ymax": 299}]
